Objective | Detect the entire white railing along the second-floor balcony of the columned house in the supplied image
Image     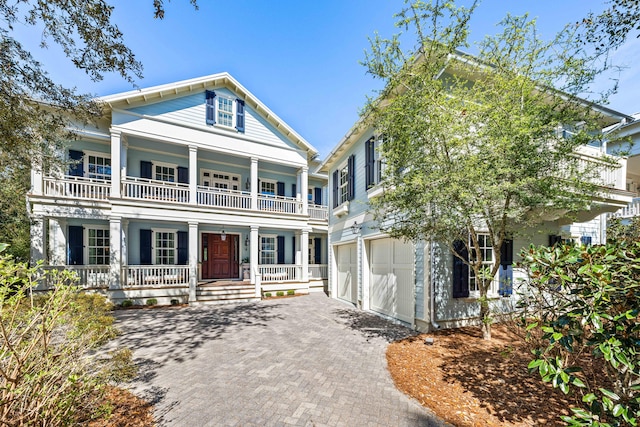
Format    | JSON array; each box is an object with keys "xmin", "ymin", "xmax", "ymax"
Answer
[{"xmin": 43, "ymin": 176, "xmax": 328, "ymax": 221}]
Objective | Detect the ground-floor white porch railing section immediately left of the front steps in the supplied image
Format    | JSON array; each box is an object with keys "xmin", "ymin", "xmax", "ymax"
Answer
[{"xmin": 122, "ymin": 265, "xmax": 189, "ymax": 288}]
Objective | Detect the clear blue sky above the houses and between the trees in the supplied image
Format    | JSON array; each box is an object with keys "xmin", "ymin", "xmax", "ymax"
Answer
[{"xmin": 20, "ymin": 0, "xmax": 640, "ymax": 158}]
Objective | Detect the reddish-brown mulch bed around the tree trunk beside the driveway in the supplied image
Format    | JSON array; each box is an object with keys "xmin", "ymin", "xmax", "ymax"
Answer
[{"xmin": 387, "ymin": 325, "xmax": 579, "ymax": 427}]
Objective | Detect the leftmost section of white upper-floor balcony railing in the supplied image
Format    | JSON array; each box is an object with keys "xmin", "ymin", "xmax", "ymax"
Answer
[{"xmin": 43, "ymin": 176, "xmax": 111, "ymax": 200}]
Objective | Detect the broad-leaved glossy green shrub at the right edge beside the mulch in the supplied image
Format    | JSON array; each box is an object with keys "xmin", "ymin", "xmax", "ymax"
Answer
[{"xmin": 521, "ymin": 240, "xmax": 640, "ymax": 426}]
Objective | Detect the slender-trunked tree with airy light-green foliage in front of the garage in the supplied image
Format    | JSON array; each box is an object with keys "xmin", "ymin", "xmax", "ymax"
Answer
[{"xmin": 364, "ymin": 1, "xmax": 613, "ymax": 339}]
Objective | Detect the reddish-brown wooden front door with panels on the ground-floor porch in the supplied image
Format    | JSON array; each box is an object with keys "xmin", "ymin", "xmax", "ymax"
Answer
[{"xmin": 202, "ymin": 233, "xmax": 239, "ymax": 279}]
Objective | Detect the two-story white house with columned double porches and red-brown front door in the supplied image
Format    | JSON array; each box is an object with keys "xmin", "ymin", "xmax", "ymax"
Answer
[{"xmin": 28, "ymin": 73, "xmax": 328, "ymax": 303}]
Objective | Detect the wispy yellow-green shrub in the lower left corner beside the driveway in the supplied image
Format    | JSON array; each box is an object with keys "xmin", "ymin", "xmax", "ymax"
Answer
[{"xmin": 0, "ymin": 245, "xmax": 133, "ymax": 426}]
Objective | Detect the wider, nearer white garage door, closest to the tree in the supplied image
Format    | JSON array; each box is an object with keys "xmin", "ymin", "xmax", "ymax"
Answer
[{"xmin": 369, "ymin": 239, "xmax": 415, "ymax": 323}]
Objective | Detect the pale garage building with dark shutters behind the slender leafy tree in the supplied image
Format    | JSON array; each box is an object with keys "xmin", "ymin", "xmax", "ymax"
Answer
[{"xmin": 320, "ymin": 92, "xmax": 640, "ymax": 331}]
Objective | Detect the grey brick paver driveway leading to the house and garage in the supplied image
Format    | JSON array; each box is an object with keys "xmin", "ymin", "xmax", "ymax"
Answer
[{"xmin": 116, "ymin": 294, "xmax": 443, "ymax": 426}]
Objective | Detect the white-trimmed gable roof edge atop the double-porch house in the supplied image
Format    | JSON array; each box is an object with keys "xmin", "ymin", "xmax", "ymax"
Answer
[{"xmin": 98, "ymin": 72, "xmax": 318, "ymax": 158}]
